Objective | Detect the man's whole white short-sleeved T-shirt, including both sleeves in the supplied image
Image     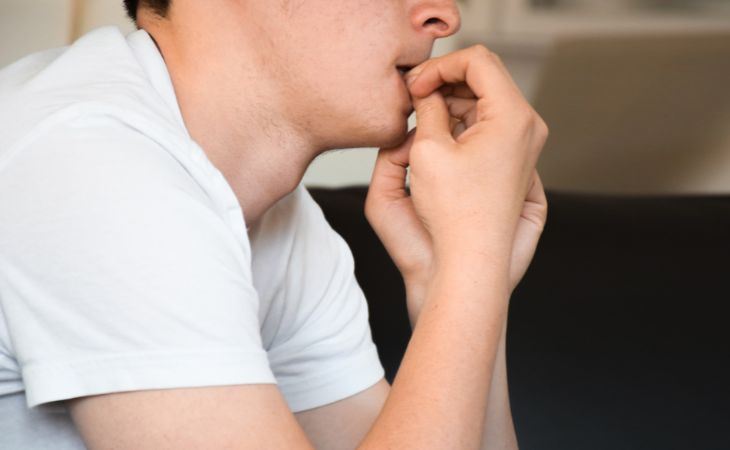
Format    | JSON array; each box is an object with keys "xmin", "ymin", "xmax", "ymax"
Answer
[{"xmin": 0, "ymin": 28, "xmax": 383, "ymax": 449}]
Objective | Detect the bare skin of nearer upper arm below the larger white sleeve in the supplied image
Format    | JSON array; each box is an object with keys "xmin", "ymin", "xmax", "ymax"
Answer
[{"xmin": 68, "ymin": 384, "xmax": 312, "ymax": 450}]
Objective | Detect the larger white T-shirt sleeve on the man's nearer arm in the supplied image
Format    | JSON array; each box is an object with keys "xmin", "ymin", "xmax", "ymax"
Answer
[{"xmin": 0, "ymin": 120, "xmax": 275, "ymax": 406}]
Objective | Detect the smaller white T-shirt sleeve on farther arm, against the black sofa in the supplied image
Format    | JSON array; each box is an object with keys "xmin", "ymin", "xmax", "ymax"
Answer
[{"xmin": 254, "ymin": 186, "xmax": 384, "ymax": 412}]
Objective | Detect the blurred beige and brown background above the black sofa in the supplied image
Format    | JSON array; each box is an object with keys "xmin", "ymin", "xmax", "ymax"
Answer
[{"xmin": 0, "ymin": 0, "xmax": 730, "ymax": 193}]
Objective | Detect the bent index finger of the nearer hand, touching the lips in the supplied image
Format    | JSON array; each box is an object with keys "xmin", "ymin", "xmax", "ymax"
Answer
[{"xmin": 407, "ymin": 46, "xmax": 521, "ymax": 101}]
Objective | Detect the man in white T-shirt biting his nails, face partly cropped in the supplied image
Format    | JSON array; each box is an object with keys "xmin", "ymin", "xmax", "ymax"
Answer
[{"xmin": 0, "ymin": 0, "xmax": 546, "ymax": 449}]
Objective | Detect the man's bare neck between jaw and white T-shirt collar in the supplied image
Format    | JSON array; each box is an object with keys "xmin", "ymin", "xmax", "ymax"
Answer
[{"xmin": 143, "ymin": 11, "xmax": 323, "ymax": 226}]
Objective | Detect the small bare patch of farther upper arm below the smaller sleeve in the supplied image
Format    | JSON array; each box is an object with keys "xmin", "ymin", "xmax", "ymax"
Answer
[{"xmin": 296, "ymin": 379, "xmax": 390, "ymax": 450}]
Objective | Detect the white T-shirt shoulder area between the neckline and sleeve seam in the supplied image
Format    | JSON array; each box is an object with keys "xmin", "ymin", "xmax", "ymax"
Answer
[{"xmin": 0, "ymin": 27, "xmax": 182, "ymax": 158}]
